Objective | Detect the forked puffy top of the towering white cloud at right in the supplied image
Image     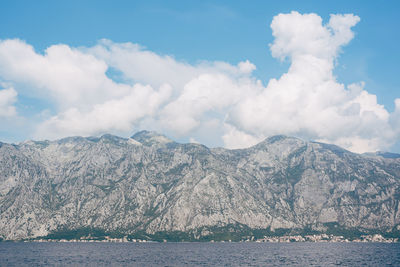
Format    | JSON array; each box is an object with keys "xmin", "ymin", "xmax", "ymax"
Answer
[{"xmin": 271, "ymin": 11, "xmax": 360, "ymax": 61}]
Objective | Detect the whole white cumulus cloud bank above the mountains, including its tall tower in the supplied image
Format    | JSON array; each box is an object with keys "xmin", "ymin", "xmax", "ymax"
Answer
[{"xmin": 0, "ymin": 12, "xmax": 400, "ymax": 152}]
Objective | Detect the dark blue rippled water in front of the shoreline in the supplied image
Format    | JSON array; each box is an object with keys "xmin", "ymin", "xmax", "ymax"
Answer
[{"xmin": 0, "ymin": 242, "xmax": 400, "ymax": 266}]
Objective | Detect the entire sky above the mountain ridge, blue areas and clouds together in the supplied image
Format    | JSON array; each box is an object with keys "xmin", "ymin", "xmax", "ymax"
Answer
[{"xmin": 0, "ymin": 0, "xmax": 400, "ymax": 153}]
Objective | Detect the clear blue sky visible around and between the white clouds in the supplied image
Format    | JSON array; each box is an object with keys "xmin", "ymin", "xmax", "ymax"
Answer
[{"xmin": 0, "ymin": 0, "xmax": 400, "ymax": 152}]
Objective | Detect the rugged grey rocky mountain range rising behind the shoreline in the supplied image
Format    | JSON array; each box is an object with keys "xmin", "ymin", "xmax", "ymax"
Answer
[{"xmin": 0, "ymin": 131, "xmax": 400, "ymax": 240}]
